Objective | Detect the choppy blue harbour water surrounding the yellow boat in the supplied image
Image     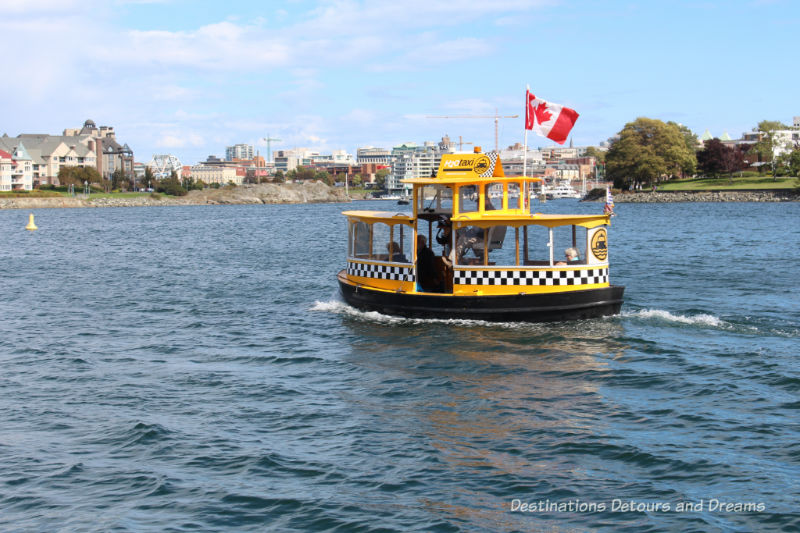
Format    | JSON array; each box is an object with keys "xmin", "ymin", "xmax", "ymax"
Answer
[{"xmin": 0, "ymin": 201, "xmax": 800, "ymax": 532}]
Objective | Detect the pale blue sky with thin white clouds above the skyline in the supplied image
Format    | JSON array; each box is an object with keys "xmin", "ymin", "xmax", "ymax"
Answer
[{"xmin": 0, "ymin": 0, "xmax": 800, "ymax": 165}]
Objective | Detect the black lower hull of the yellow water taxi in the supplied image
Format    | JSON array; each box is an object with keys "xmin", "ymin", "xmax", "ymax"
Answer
[{"xmin": 339, "ymin": 274, "xmax": 625, "ymax": 322}]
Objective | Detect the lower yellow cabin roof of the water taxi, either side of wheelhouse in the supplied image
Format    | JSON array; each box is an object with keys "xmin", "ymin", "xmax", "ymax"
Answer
[{"xmin": 342, "ymin": 211, "xmax": 611, "ymax": 228}]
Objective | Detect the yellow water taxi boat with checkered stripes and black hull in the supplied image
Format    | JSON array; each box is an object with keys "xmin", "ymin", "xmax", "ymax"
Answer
[{"xmin": 338, "ymin": 147, "xmax": 625, "ymax": 322}]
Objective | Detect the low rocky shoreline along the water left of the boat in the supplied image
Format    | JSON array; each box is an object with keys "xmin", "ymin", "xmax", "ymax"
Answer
[{"xmin": 0, "ymin": 182, "xmax": 351, "ymax": 209}]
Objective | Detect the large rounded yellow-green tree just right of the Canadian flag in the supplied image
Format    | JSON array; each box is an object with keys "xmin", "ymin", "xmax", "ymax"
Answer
[{"xmin": 606, "ymin": 117, "xmax": 697, "ymax": 188}]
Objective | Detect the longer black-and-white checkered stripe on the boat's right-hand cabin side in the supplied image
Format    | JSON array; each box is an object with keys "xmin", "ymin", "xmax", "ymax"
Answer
[{"xmin": 453, "ymin": 267, "xmax": 608, "ymax": 286}]
